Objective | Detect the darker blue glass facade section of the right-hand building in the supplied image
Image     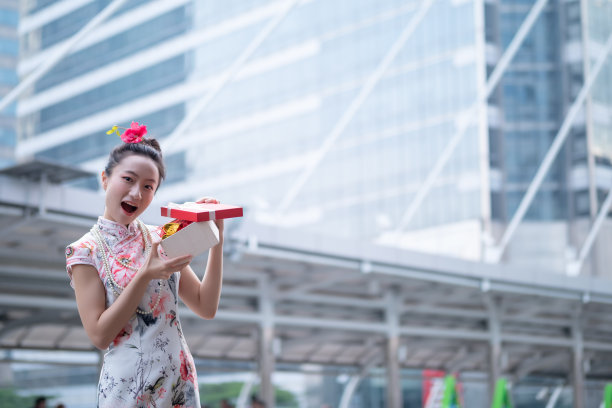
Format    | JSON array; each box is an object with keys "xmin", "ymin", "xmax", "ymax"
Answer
[{"xmin": 488, "ymin": 0, "xmax": 567, "ymax": 222}]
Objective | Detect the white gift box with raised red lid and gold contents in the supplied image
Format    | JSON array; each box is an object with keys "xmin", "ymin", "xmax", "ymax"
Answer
[{"xmin": 160, "ymin": 202, "xmax": 242, "ymax": 258}]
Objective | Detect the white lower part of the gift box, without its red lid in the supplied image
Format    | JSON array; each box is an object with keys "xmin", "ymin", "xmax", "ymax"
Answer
[{"xmin": 160, "ymin": 221, "xmax": 219, "ymax": 258}]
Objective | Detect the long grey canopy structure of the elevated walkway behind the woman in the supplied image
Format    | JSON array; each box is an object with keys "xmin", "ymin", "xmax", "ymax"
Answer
[{"xmin": 0, "ymin": 161, "xmax": 612, "ymax": 406}]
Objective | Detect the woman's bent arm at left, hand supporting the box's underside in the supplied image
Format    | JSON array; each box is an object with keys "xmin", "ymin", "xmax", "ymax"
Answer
[{"xmin": 72, "ymin": 243, "xmax": 191, "ymax": 350}]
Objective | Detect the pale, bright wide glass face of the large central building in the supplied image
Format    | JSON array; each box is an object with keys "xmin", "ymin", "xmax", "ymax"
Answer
[{"xmin": 185, "ymin": 1, "xmax": 480, "ymax": 239}]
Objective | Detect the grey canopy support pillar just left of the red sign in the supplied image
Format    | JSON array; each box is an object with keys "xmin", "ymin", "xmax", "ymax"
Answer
[{"xmin": 386, "ymin": 292, "xmax": 403, "ymax": 408}]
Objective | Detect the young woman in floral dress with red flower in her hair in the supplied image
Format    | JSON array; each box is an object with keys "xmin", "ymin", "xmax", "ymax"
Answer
[{"xmin": 66, "ymin": 124, "xmax": 223, "ymax": 408}]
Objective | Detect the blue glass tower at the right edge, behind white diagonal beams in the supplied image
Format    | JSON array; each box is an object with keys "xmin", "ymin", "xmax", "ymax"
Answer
[{"xmin": 485, "ymin": 1, "xmax": 612, "ymax": 272}]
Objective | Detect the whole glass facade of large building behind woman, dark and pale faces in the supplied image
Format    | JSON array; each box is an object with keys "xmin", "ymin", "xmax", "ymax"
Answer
[{"xmin": 19, "ymin": 0, "xmax": 486, "ymax": 253}]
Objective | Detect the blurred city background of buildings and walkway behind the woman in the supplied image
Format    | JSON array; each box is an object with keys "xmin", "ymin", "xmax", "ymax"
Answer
[{"xmin": 0, "ymin": 0, "xmax": 612, "ymax": 408}]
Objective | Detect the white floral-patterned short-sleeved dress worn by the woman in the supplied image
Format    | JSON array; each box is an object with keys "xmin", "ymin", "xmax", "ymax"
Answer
[{"xmin": 66, "ymin": 217, "xmax": 200, "ymax": 408}]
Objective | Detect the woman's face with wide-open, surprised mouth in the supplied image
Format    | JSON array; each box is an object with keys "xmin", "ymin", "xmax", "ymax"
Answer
[{"xmin": 102, "ymin": 154, "xmax": 159, "ymax": 225}]
